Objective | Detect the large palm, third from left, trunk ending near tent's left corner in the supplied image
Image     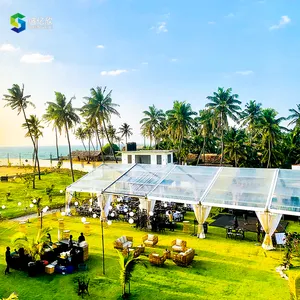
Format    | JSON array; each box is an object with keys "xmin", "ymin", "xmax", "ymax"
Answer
[{"xmin": 47, "ymin": 92, "xmax": 80, "ymax": 182}]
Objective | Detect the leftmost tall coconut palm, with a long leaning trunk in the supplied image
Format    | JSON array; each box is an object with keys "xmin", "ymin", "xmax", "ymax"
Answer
[{"xmin": 3, "ymin": 84, "xmax": 37, "ymax": 188}]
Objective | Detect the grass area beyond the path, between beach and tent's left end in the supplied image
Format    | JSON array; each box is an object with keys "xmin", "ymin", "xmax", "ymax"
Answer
[{"xmin": 0, "ymin": 170, "xmax": 84, "ymax": 218}]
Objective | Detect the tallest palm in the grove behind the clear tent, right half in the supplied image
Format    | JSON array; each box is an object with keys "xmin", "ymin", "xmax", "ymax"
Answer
[{"xmin": 206, "ymin": 87, "xmax": 241, "ymax": 164}]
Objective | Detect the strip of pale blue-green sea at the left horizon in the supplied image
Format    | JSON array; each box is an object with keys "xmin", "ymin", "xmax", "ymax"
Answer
[{"xmin": 0, "ymin": 145, "xmax": 84, "ymax": 161}]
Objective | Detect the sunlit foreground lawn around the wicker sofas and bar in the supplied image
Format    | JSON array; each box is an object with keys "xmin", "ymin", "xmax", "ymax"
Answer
[{"xmin": 0, "ymin": 213, "xmax": 296, "ymax": 300}]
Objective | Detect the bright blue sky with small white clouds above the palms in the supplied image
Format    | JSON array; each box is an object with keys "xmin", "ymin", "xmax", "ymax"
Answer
[{"xmin": 0, "ymin": 0, "xmax": 300, "ymax": 145}]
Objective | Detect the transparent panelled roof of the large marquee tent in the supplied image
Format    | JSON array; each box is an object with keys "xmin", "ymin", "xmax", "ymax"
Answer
[{"xmin": 67, "ymin": 164, "xmax": 300, "ymax": 216}]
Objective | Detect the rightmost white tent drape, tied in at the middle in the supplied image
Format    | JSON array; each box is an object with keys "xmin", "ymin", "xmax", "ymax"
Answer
[{"xmin": 256, "ymin": 211, "xmax": 282, "ymax": 250}]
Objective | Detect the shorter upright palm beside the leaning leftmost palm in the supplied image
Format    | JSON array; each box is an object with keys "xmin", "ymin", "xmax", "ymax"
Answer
[{"xmin": 22, "ymin": 115, "xmax": 44, "ymax": 180}]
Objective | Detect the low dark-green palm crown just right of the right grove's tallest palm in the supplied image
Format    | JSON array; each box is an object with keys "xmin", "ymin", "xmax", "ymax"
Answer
[{"xmin": 224, "ymin": 127, "xmax": 247, "ymax": 167}]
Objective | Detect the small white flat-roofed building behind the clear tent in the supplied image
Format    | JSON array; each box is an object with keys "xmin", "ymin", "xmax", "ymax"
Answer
[{"xmin": 122, "ymin": 150, "xmax": 173, "ymax": 165}]
